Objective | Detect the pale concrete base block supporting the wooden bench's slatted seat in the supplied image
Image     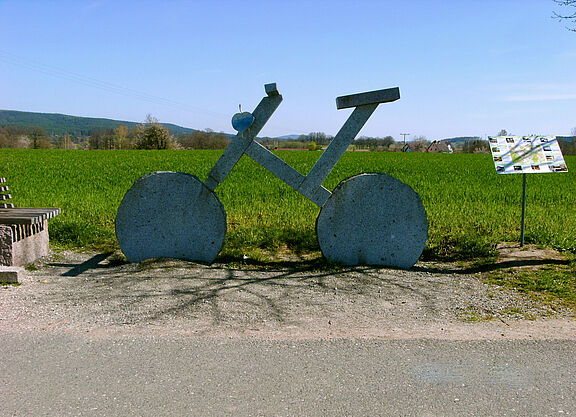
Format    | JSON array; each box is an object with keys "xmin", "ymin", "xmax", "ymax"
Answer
[{"xmin": 0, "ymin": 220, "xmax": 49, "ymax": 266}]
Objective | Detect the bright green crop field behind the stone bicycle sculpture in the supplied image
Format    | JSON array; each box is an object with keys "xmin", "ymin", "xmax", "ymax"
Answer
[{"xmin": 0, "ymin": 149, "xmax": 576, "ymax": 260}]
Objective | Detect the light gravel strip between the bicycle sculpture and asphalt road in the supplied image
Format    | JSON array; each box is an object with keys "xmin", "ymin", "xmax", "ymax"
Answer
[{"xmin": 0, "ymin": 252, "xmax": 576, "ymax": 340}]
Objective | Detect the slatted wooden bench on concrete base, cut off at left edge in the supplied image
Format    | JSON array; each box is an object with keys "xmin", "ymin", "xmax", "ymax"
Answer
[{"xmin": 0, "ymin": 178, "xmax": 60, "ymax": 266}]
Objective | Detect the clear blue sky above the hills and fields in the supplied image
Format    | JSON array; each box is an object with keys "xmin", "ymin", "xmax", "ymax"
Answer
[{"xmin": 0, "ymin": 0, "xmax": 576, "ymax": 140}]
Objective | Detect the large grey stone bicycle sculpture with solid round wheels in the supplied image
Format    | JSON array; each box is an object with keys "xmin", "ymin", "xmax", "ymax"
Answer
[{"xmin": 116, "ymin": 84, "xmax": 428, "ymax": 269}]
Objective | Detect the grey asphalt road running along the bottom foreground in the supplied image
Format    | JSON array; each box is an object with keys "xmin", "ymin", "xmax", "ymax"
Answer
[{"xmin": 0, "ymin": 331, "xmax": 576, "ymax": 416}]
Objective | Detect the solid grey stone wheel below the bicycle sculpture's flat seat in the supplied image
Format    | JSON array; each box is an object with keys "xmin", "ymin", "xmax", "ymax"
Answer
[{"xmin": 316, "ymin": 174, "xmax": 428, "ymax": 269}]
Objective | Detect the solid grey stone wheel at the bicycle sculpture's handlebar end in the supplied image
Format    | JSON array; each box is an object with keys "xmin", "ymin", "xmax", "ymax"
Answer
[{"xmin": 116, "ymin": 172, "xmax": 226, "ymax": 264}]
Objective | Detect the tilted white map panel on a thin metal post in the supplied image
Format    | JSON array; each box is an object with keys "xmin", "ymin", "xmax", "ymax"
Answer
[{"xmin": 488, "ymin": 136, "xmax": 568, "ymax": 174}]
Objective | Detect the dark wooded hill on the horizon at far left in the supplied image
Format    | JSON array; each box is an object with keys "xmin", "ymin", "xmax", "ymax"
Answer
[{"xmin": 0, "ymin": 110, "xmax": 196, "ymax": 136}]
